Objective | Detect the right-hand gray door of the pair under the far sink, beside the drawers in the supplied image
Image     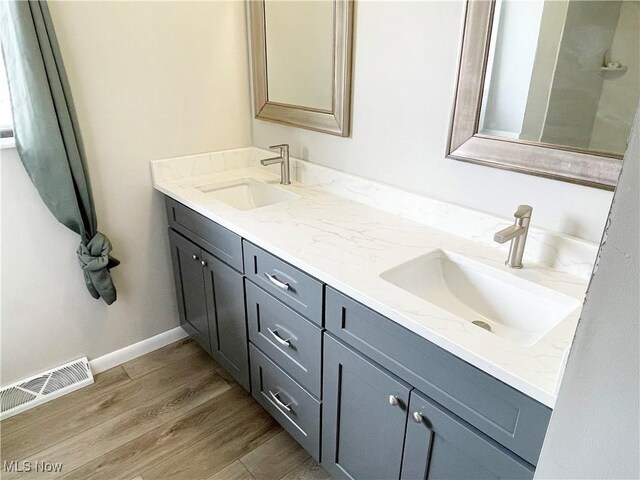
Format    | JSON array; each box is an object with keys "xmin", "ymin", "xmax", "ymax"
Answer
[{"xmin": 202, "ymin": 250, "xmax": 250, "ymax": 391}]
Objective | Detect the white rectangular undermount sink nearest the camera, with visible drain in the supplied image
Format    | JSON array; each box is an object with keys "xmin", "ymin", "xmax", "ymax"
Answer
[{"xmin": 380, "ymin": 250, "xmax": 580, "ymax": 346}]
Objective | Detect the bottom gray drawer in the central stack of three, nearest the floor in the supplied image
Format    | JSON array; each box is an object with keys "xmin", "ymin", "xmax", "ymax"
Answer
[{"xmin": 249, "ymin": 343, "xmax": 320, "ymax": 461}]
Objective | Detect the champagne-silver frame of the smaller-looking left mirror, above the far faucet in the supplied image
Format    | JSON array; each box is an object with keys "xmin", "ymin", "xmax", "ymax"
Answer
[{"xmin": 247, "ymin": 0, "xmax": 354, "ymax": 137}]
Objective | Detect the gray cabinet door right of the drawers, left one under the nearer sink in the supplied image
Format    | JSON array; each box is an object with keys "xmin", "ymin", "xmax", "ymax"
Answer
[{"xmin": 322, "ymin": 334, "xmax": 410, "ymax": 479}]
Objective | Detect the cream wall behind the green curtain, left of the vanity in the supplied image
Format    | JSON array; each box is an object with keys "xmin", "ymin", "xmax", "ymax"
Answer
[{"xmin": 0, "ymin": 2, "xmax": 250, "ymax": 385}]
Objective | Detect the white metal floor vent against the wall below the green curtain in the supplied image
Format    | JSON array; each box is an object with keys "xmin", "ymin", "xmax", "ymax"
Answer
[{"xmin": 0, "ymin": 358, "xmax": 93, "ymax": 420}]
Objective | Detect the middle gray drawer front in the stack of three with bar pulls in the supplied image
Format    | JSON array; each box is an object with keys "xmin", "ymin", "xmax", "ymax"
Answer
[{"xmin": 245, "ymin": 280, "xmax": 322, "ymax": 398}]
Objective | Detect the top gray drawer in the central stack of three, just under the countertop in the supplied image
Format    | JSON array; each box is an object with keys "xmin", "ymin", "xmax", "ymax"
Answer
[{"xmin": 243, "ymin": 240, "xmax": 322, "ymax": 326}]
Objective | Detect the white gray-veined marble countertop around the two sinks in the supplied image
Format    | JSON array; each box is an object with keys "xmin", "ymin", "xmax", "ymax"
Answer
[{"xmin": 152, "ymin": 149, "xmax": 587, "ymax": 408}]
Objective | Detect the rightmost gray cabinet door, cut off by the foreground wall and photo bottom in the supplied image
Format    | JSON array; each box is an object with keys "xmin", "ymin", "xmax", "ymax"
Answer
[{"xmin": 402, "ymin": 390, "xmax": 534, "ymax": 480}]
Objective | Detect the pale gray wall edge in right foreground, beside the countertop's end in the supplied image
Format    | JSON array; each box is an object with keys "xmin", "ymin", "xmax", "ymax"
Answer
[{"xmin": 536, "ymin": 110, "xmax": 640, "ymax": 479}]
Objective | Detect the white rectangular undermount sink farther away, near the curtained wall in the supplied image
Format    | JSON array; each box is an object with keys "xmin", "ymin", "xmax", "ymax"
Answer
[{"xmin": 196, "ymin": 178, "xmax": 300, "ymax": 210}]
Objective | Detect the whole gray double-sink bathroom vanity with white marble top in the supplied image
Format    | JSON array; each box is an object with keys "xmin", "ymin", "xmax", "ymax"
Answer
[{"xmin": 154, "ymin": 149, "xmax": 584, "ymax": 479}]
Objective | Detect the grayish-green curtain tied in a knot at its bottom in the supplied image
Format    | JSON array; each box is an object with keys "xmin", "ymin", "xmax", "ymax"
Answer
[{"xmin": 0, "ymin": 0, "xmax": 119, "ymax": 304}]
